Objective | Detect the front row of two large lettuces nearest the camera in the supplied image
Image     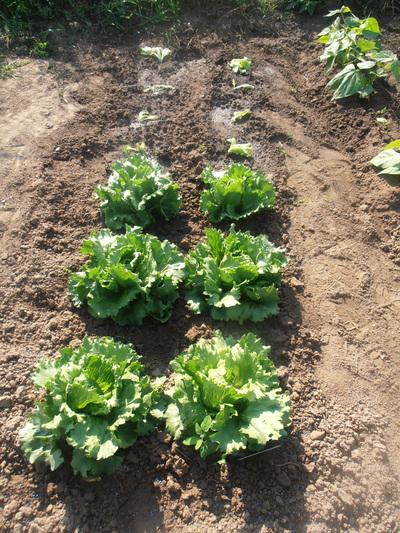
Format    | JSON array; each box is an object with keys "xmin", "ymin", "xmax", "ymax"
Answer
[{"xmin": 21, "ymin": 332, "xmax": 290, "ymax": 478}]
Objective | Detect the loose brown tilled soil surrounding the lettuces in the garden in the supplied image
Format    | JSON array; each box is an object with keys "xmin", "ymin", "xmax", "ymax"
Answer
[{"xmin": 0, "ymin": 5, "xmax": 400, "ymax": 533}]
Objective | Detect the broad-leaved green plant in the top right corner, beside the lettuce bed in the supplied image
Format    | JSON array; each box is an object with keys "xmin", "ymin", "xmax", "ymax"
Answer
[{"xmin": 317, "ymin": 6, "xmax": 400, "ymax": 100}]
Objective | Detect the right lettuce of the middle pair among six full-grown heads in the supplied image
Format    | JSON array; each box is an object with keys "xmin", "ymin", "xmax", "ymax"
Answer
[{"xmin": 186, "ymin": 226, "xmax": 288, "ymax": 324}]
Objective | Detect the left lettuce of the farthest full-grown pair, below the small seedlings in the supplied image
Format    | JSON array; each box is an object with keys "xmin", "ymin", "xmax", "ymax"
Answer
[{"xmin": 95, "ymin": 151, "xmax": 181, "ymax": 230}]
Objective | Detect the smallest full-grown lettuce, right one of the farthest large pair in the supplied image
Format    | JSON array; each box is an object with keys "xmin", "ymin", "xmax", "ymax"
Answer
[{"xmin": 200, "ymin": 164, "xmax": 275, "ymax": 223}]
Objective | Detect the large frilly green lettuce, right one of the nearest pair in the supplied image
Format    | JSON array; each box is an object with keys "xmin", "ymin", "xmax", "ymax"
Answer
[{"xmin": 165, "ymin": 332, "xmax": 290, "ymax": 459}]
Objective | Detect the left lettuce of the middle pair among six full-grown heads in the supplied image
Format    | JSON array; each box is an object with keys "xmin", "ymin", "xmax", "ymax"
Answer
[{"xmin": 69, "ymin": 226, "xmax": 184, "ymax": 325}]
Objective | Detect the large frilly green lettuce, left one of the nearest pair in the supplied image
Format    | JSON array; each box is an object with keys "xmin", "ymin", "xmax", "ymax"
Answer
[{"xmin": 20, "ymin": 337, "xmax": 161, "ymax": 478}]
